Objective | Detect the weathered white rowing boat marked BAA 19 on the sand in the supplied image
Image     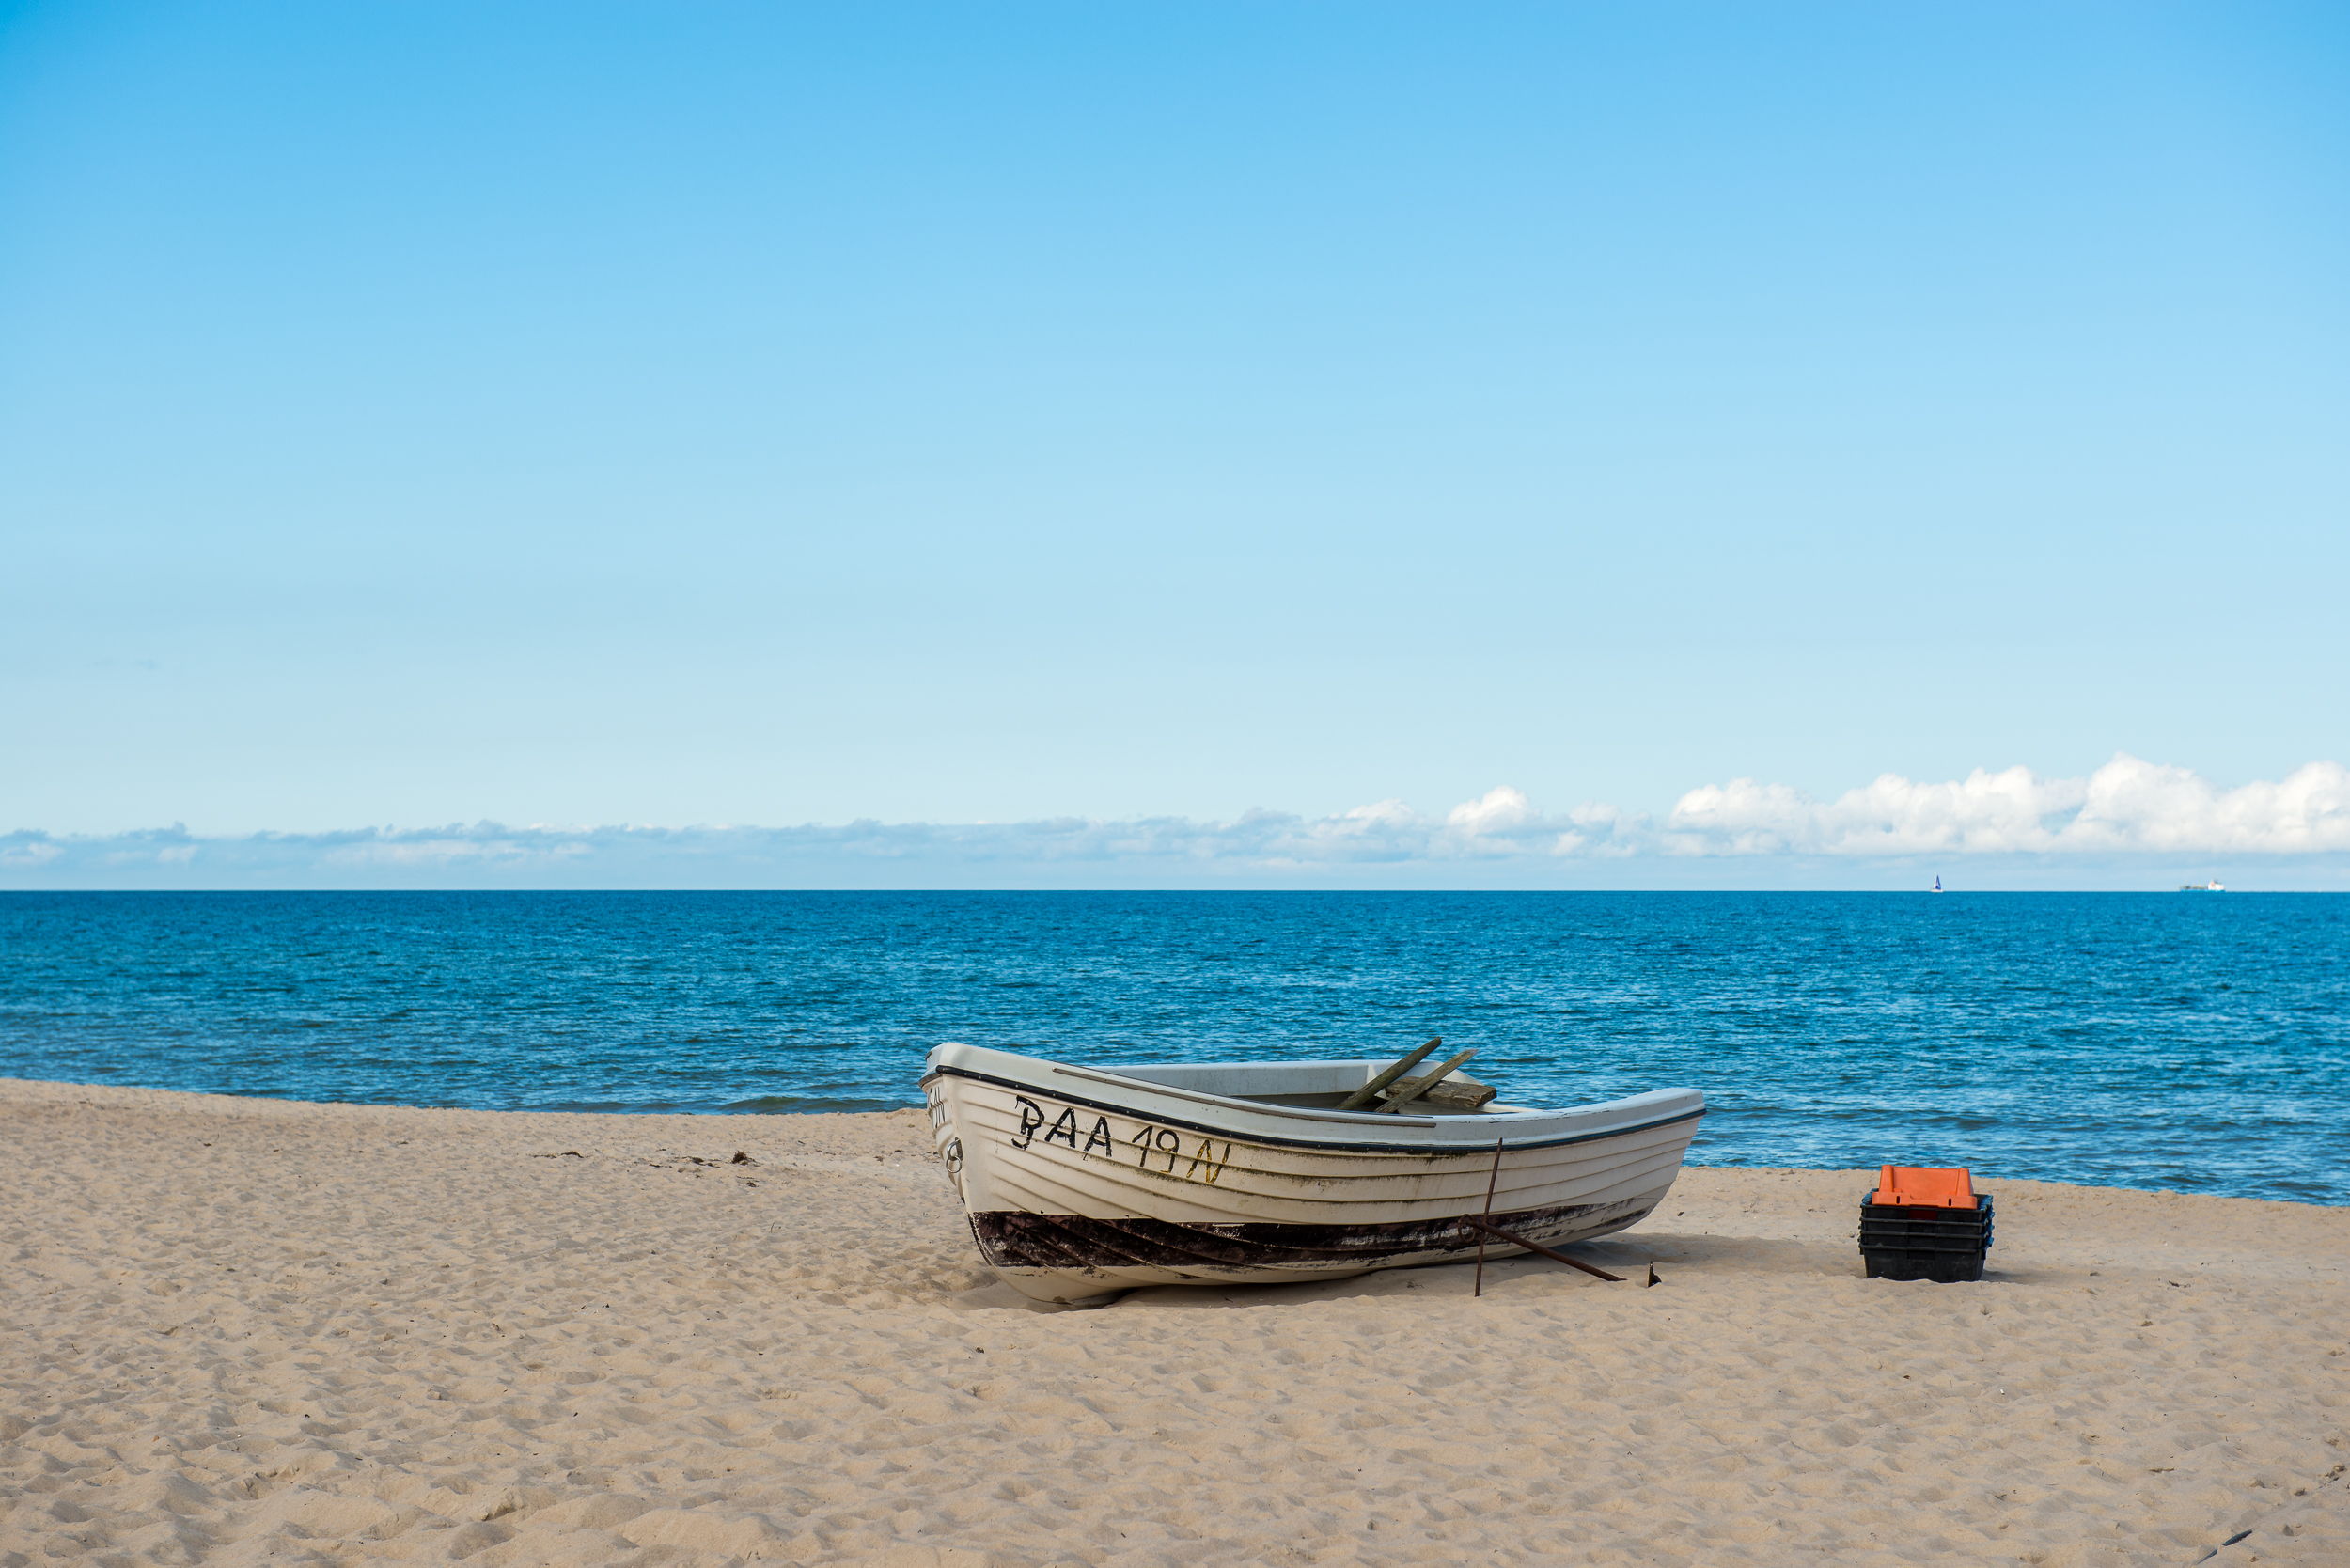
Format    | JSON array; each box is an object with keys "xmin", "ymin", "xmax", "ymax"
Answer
[{"xmin": 921, "ymin": 1042, "xmax": 1706, "ymax": 1305}]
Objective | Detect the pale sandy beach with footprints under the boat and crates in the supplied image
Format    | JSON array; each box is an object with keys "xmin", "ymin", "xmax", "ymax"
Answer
[{"xmin": 0, "ymin": 1081, "xmax": 2350, "ymax": 1568}]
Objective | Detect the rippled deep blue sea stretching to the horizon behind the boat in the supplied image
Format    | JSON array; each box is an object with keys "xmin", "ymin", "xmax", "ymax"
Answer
[{"xmin": 0, "ymin": 893, "xmax": 2350, "ymax": 1203}]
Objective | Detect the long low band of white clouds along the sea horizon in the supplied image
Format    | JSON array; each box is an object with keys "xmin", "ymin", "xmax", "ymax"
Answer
[{"xmin": 0, "ymin": 755, "xmax": 2350, "ymax": 888}]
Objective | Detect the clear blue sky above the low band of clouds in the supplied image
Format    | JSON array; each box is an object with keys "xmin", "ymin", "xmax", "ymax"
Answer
[{"xmin": 0, "ymin": 3, "xmax": 2350, "ymax": 879}]
